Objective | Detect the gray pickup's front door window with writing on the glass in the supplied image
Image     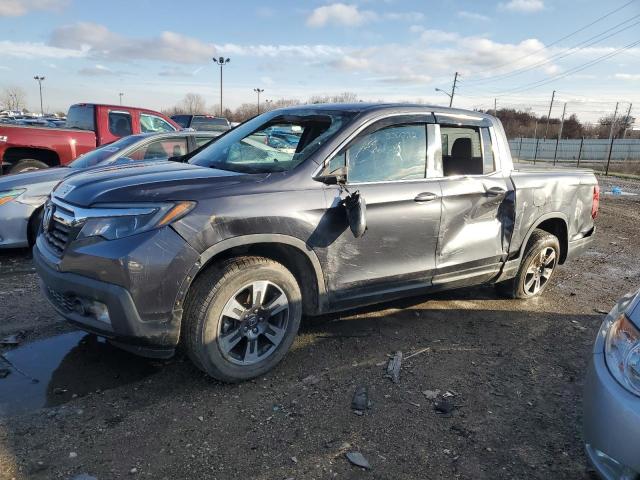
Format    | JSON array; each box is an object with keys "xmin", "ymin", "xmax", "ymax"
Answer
[{"xmin": 347, "ymin": 124, "xmax": 427, "ymax": 183}]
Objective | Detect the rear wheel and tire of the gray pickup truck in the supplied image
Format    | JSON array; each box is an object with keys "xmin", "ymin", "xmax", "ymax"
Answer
[{"xmin": 496, "ymin": 229, "xmax": 560, "ymax": 298}]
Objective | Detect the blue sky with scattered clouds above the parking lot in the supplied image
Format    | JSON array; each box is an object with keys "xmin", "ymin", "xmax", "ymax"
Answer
[{"xmin": 0, "ymin": 0, "xmax": 640, "ymax": 119}]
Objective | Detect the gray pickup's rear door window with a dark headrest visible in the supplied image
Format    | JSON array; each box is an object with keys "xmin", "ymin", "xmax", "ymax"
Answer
[{"xmin": 440, "ymin": 125, "xmax": 484, "ymax": 177}]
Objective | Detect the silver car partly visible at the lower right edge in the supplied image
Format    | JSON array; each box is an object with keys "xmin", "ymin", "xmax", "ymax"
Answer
[{"xmin": 584, "ymin": 290, "xmax": 640, "ymax": 480}]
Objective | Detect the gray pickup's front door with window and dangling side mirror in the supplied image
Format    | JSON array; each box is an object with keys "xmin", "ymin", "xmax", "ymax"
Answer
[{"xmin": 321, "ymin": 117, "xmax": 441, "ymax": 304}]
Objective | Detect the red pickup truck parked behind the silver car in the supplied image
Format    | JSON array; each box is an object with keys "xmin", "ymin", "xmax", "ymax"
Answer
[{"xmin": 0, "ymin": 103, "xmax": 181, "ymax": 173}]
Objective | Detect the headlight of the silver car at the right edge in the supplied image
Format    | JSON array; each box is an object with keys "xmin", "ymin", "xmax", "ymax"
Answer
[{"xmin": 604, "ymin": 313, "xmax": 640, "ymax": 395}]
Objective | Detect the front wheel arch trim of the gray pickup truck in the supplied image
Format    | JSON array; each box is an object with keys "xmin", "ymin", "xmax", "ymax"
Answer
[{"xmin": 184, "ymin": 234, "xmax": 328, "ymax": 315}]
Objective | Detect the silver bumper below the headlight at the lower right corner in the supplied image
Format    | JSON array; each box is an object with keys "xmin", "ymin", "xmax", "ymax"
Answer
[{"xmin": 584, "ymin": 353, "xmax": 640, "ymax": 480}]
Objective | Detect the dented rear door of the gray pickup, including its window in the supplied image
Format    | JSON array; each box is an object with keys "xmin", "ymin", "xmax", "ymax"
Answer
[{"xmin": 433, "ymin": 115, "xmax": 515, "ymax": 286}]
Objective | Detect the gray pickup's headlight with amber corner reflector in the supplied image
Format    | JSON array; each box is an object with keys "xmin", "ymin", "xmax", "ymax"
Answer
[{"xmin": 77, "ymin": 202, "xmax": 195, "ymax": 240}]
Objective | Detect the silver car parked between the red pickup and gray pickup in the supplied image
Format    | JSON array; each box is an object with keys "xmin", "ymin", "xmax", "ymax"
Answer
[{"xmin": 0, "ymin": 131, "xmax": 220, "ymax": 249}]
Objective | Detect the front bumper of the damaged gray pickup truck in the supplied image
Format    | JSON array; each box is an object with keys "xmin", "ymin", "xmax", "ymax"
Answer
[{"xmin": 33, "ymin": 228, "xmax": 197, "ymax": 358}]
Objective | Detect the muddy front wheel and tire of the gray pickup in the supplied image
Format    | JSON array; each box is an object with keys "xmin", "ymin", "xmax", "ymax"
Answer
[{"xmin": 183, "ymin": 257, "xmax": 302, "ymax": 383}]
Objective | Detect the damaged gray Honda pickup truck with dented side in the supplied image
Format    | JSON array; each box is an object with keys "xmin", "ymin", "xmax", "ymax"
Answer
[{"xmin": 34, "ymin": 103, "xmax": 599, "ymax": 382}]
